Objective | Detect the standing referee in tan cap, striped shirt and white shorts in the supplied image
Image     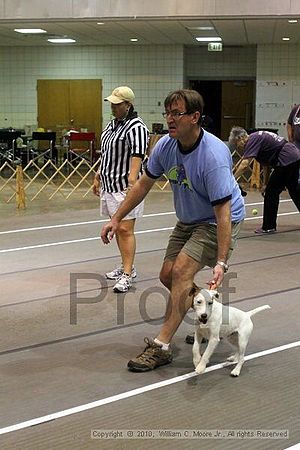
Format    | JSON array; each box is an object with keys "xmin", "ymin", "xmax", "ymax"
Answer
[{"xmin": 93, "ymin": 86, "xmax": 149, "ymax": 292}]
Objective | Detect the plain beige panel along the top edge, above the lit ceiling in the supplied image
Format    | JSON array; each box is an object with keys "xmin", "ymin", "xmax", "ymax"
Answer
[{"xmin": 0, "ymin": 0, "xmax": 300, "ymax": 19}]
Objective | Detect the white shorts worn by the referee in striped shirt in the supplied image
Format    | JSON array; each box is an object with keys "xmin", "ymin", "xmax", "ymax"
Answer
[{"xmin": 100, "ymin": 191, "xmax": 144, "ymax": 220}]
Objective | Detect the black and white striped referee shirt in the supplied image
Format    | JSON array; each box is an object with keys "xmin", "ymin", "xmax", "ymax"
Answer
[{"xmin": 99, "ymin": 112, "xmax": 149, "ymax": 192}]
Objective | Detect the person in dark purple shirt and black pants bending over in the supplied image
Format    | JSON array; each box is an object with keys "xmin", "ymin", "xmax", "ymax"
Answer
[{"xmin": 229, "ymin": 127, "xmax": 300, "ymax": 234}]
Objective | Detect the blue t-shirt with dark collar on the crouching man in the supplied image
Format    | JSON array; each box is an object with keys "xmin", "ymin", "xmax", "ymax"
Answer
[{"xmin": 146, "ymin": 130, "xmax": 245, "ymax": 224}]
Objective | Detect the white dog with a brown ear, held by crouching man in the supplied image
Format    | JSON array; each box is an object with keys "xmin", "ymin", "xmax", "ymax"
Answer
[{"xmin": 190, "ymin": 286, "xmax": 270, "ymax": 377}]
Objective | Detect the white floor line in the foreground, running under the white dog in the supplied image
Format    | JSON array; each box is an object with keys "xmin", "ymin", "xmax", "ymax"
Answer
[{"xmin": 0, "ymin": 341, "xmax": 300, "ymax": 435}]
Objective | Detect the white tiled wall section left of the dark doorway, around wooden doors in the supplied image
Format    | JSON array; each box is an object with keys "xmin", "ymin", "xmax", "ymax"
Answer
[{"xmin": 0, "ymin": 45, "xmax": 184, "ymax": 133}]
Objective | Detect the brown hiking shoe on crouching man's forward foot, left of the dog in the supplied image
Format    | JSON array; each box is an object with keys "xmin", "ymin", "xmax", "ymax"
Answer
[{"xmin": 127, "ymin": 338, "xmax": 173, "ymax": 372}]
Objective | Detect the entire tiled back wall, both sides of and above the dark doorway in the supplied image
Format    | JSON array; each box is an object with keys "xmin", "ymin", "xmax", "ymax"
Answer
[{"xmin": 0, "ymin": 44, "xmax": 300, "ymax": 141}]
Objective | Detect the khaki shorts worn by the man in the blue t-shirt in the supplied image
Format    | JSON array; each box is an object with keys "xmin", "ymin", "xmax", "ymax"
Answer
[{"xmin": 164, "ymin": 222, "xmax": 242, "ymax": 267}]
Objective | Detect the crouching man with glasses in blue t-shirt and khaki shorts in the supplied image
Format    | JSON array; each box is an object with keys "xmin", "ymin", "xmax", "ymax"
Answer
[{"xmin": 101, "ymin": 89, "xmax": 245, "ymax": 372}]
